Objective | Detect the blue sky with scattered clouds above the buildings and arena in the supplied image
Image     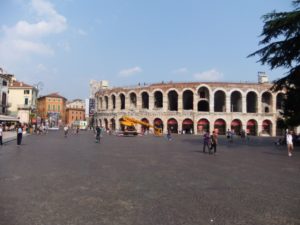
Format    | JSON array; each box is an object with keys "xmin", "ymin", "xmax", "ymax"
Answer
[{"xmin": 0, "ymin": 0, "xmax": 293, "ymax": 99}]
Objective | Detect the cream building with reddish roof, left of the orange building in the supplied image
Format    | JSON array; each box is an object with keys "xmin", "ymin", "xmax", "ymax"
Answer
[{"xmin": 8, "ymin": 81, "xmax": 38, "ymax": 123}]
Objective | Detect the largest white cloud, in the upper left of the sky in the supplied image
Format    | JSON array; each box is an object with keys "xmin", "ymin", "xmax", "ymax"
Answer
[{"xmin": 0, "ymin": 0, "xmax": 67, "ymax": 63}]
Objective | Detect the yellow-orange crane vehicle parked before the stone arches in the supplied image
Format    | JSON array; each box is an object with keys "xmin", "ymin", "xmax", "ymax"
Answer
[{"xmin": 120, "ymin": 116, "xmax": 162, "ymax": 136}]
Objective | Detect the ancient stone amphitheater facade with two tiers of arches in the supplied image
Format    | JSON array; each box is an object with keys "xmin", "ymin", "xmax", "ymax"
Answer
[{"xmin": 94, "ymin": 82, "xmax": 284, "ymax": 136}]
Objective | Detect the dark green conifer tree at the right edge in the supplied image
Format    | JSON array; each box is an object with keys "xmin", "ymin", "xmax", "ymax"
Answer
[{"xmin": 248, "ymin": 0, "xmax": 300, "ymax": 126}]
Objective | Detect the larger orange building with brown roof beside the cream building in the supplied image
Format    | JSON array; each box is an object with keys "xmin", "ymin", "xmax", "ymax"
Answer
[{"xmin": 38, "ymin": 93, "xmax": 67, "ymax": 127}]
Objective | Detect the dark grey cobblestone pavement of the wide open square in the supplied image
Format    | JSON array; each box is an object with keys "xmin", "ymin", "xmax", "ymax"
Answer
[{"xmin": 0, "ymin": 131, "xmax": 300, "ymax": 225}]
